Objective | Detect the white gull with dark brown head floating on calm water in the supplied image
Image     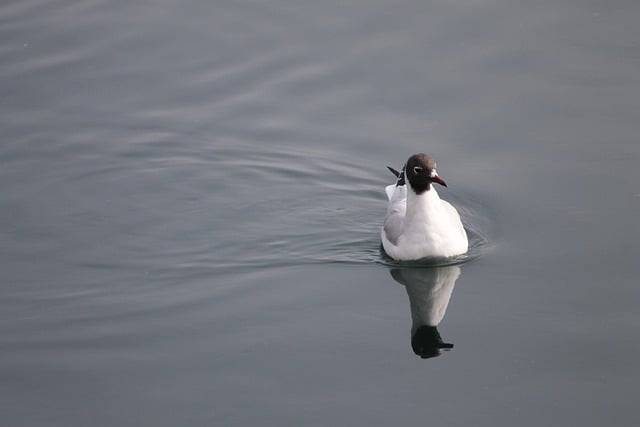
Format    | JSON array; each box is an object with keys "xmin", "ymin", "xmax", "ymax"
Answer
[{"xmin": 380, "ymin": 153, "xmax": 469, "ymax": 261}]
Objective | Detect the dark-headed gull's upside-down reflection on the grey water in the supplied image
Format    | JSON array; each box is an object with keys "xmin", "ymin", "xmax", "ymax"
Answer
[{"xmin": 391, "ymin": 265, "xmax": 460, "ymax": 359}]
